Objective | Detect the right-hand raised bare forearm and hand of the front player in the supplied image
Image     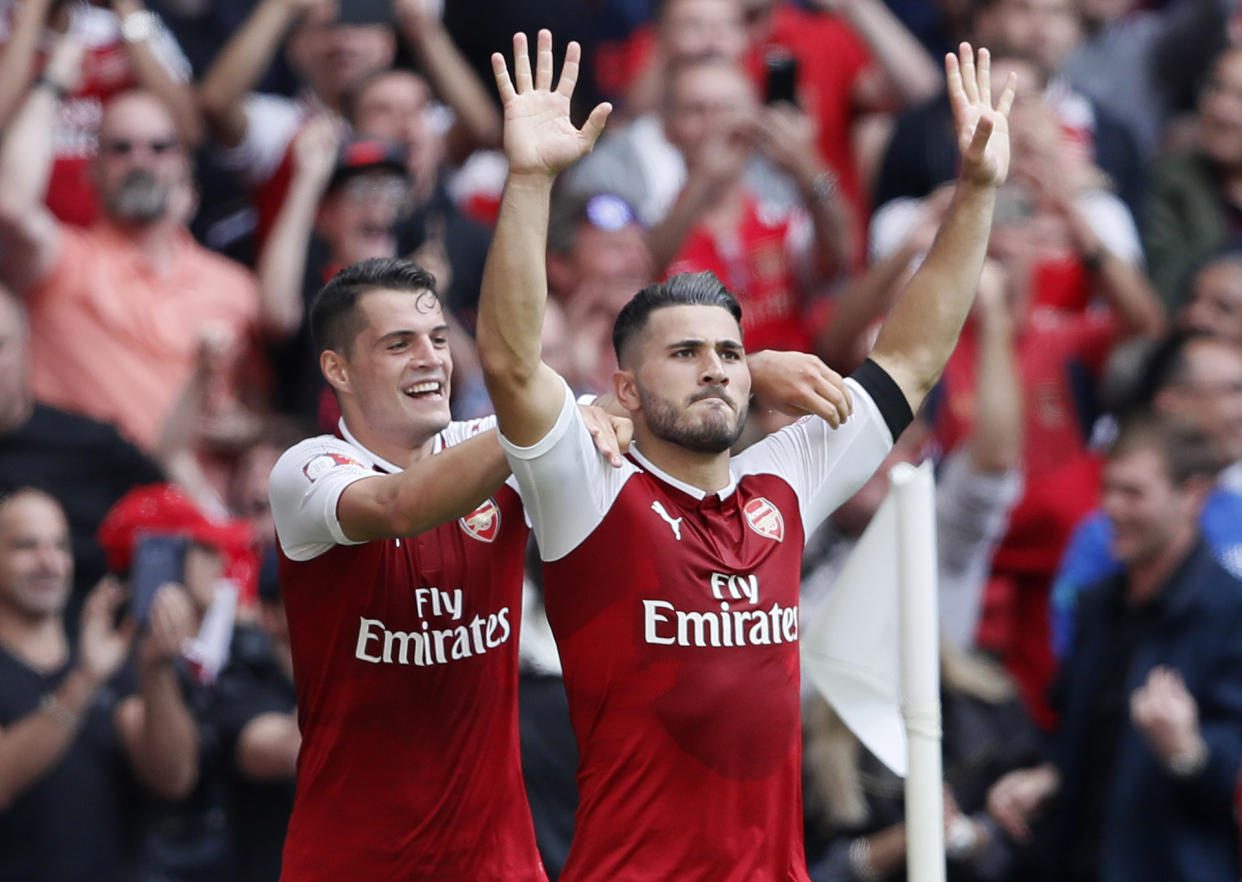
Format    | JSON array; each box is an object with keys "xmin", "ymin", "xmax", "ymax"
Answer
[{"xmin": 871, "ymin": 43, "xmax": 1015, "ymax": 410}]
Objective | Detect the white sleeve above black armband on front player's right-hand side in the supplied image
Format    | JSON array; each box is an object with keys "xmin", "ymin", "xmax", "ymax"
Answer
[{"xmin": 733, "ymin": 375, "xmax": 909, "ymax": 538}]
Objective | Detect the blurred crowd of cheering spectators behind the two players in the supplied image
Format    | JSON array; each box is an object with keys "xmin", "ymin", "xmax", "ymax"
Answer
[{"xmin": 7, "ymin": 0, "xmax": 1242, "ymax": 882}]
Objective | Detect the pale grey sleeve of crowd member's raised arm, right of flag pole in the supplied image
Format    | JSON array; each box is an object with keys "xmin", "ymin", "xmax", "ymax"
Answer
[{"xmin": 935, "ymin": 445, "xmax": 1022, "ymax": 648}]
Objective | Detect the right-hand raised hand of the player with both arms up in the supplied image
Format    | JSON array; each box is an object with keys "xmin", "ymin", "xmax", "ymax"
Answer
[{"xmin": 944, "ymin": 42, "xmax": 1017, "ymax": 186}]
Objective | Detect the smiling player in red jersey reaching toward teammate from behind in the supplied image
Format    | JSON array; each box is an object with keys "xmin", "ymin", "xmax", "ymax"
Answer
[{"xmin": 268, "ymin": 258, "xmax": 635, "ymax": 882}]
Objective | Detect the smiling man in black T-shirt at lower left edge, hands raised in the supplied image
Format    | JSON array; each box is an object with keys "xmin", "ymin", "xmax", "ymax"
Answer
[{"xmin": 0, "ymin": 488, "xmax": 197, "ymax": 882}]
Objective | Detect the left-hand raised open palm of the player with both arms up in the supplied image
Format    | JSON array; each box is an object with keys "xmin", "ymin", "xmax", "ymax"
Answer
[{"xmin": 492, "ymin": 30, "xmax": 612, "ymax": 178}]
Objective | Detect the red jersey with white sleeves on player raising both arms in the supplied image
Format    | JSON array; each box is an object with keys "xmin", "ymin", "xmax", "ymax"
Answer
[{"xmin": 502, "ymin": 361, "xmax": 912, "ymax": 882}]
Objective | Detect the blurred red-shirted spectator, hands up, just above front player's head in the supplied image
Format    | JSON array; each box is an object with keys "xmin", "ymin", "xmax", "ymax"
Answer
[{"xmin": 648, "ymin": 58, "xmax": 852, "ymax": 352}]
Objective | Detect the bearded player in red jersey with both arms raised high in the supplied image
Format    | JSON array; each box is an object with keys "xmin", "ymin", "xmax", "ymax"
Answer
[{"xmin": 478, "ymin": 31, "xmax": 1013, "ymax": 882}]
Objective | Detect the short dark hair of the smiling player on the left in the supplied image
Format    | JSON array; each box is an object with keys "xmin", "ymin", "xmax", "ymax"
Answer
[{"xmin": 311, "ymin": 257, "xmax": 440, "ymax": 354}]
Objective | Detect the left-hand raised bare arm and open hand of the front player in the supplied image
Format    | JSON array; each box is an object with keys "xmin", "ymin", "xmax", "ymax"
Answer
[{"xmin": 477, "ymin": 31, "xmax": 611, "ymax": 447}]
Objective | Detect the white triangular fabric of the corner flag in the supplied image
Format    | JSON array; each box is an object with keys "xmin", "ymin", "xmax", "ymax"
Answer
[{"xmin": 799, "ymin": 492, "xmax": 909, "ymax": 776}]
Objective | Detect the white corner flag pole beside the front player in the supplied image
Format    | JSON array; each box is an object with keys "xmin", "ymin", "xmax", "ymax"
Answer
[{"xmin": 889, "ymin": 462, "xmax": 945, "ymax": 882}]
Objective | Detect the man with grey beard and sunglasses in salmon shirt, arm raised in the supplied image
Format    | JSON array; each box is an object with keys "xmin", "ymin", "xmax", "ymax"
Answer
[{"xmin": 0, "ymin": 37, "xmax": 262, "ymax": 451}]
